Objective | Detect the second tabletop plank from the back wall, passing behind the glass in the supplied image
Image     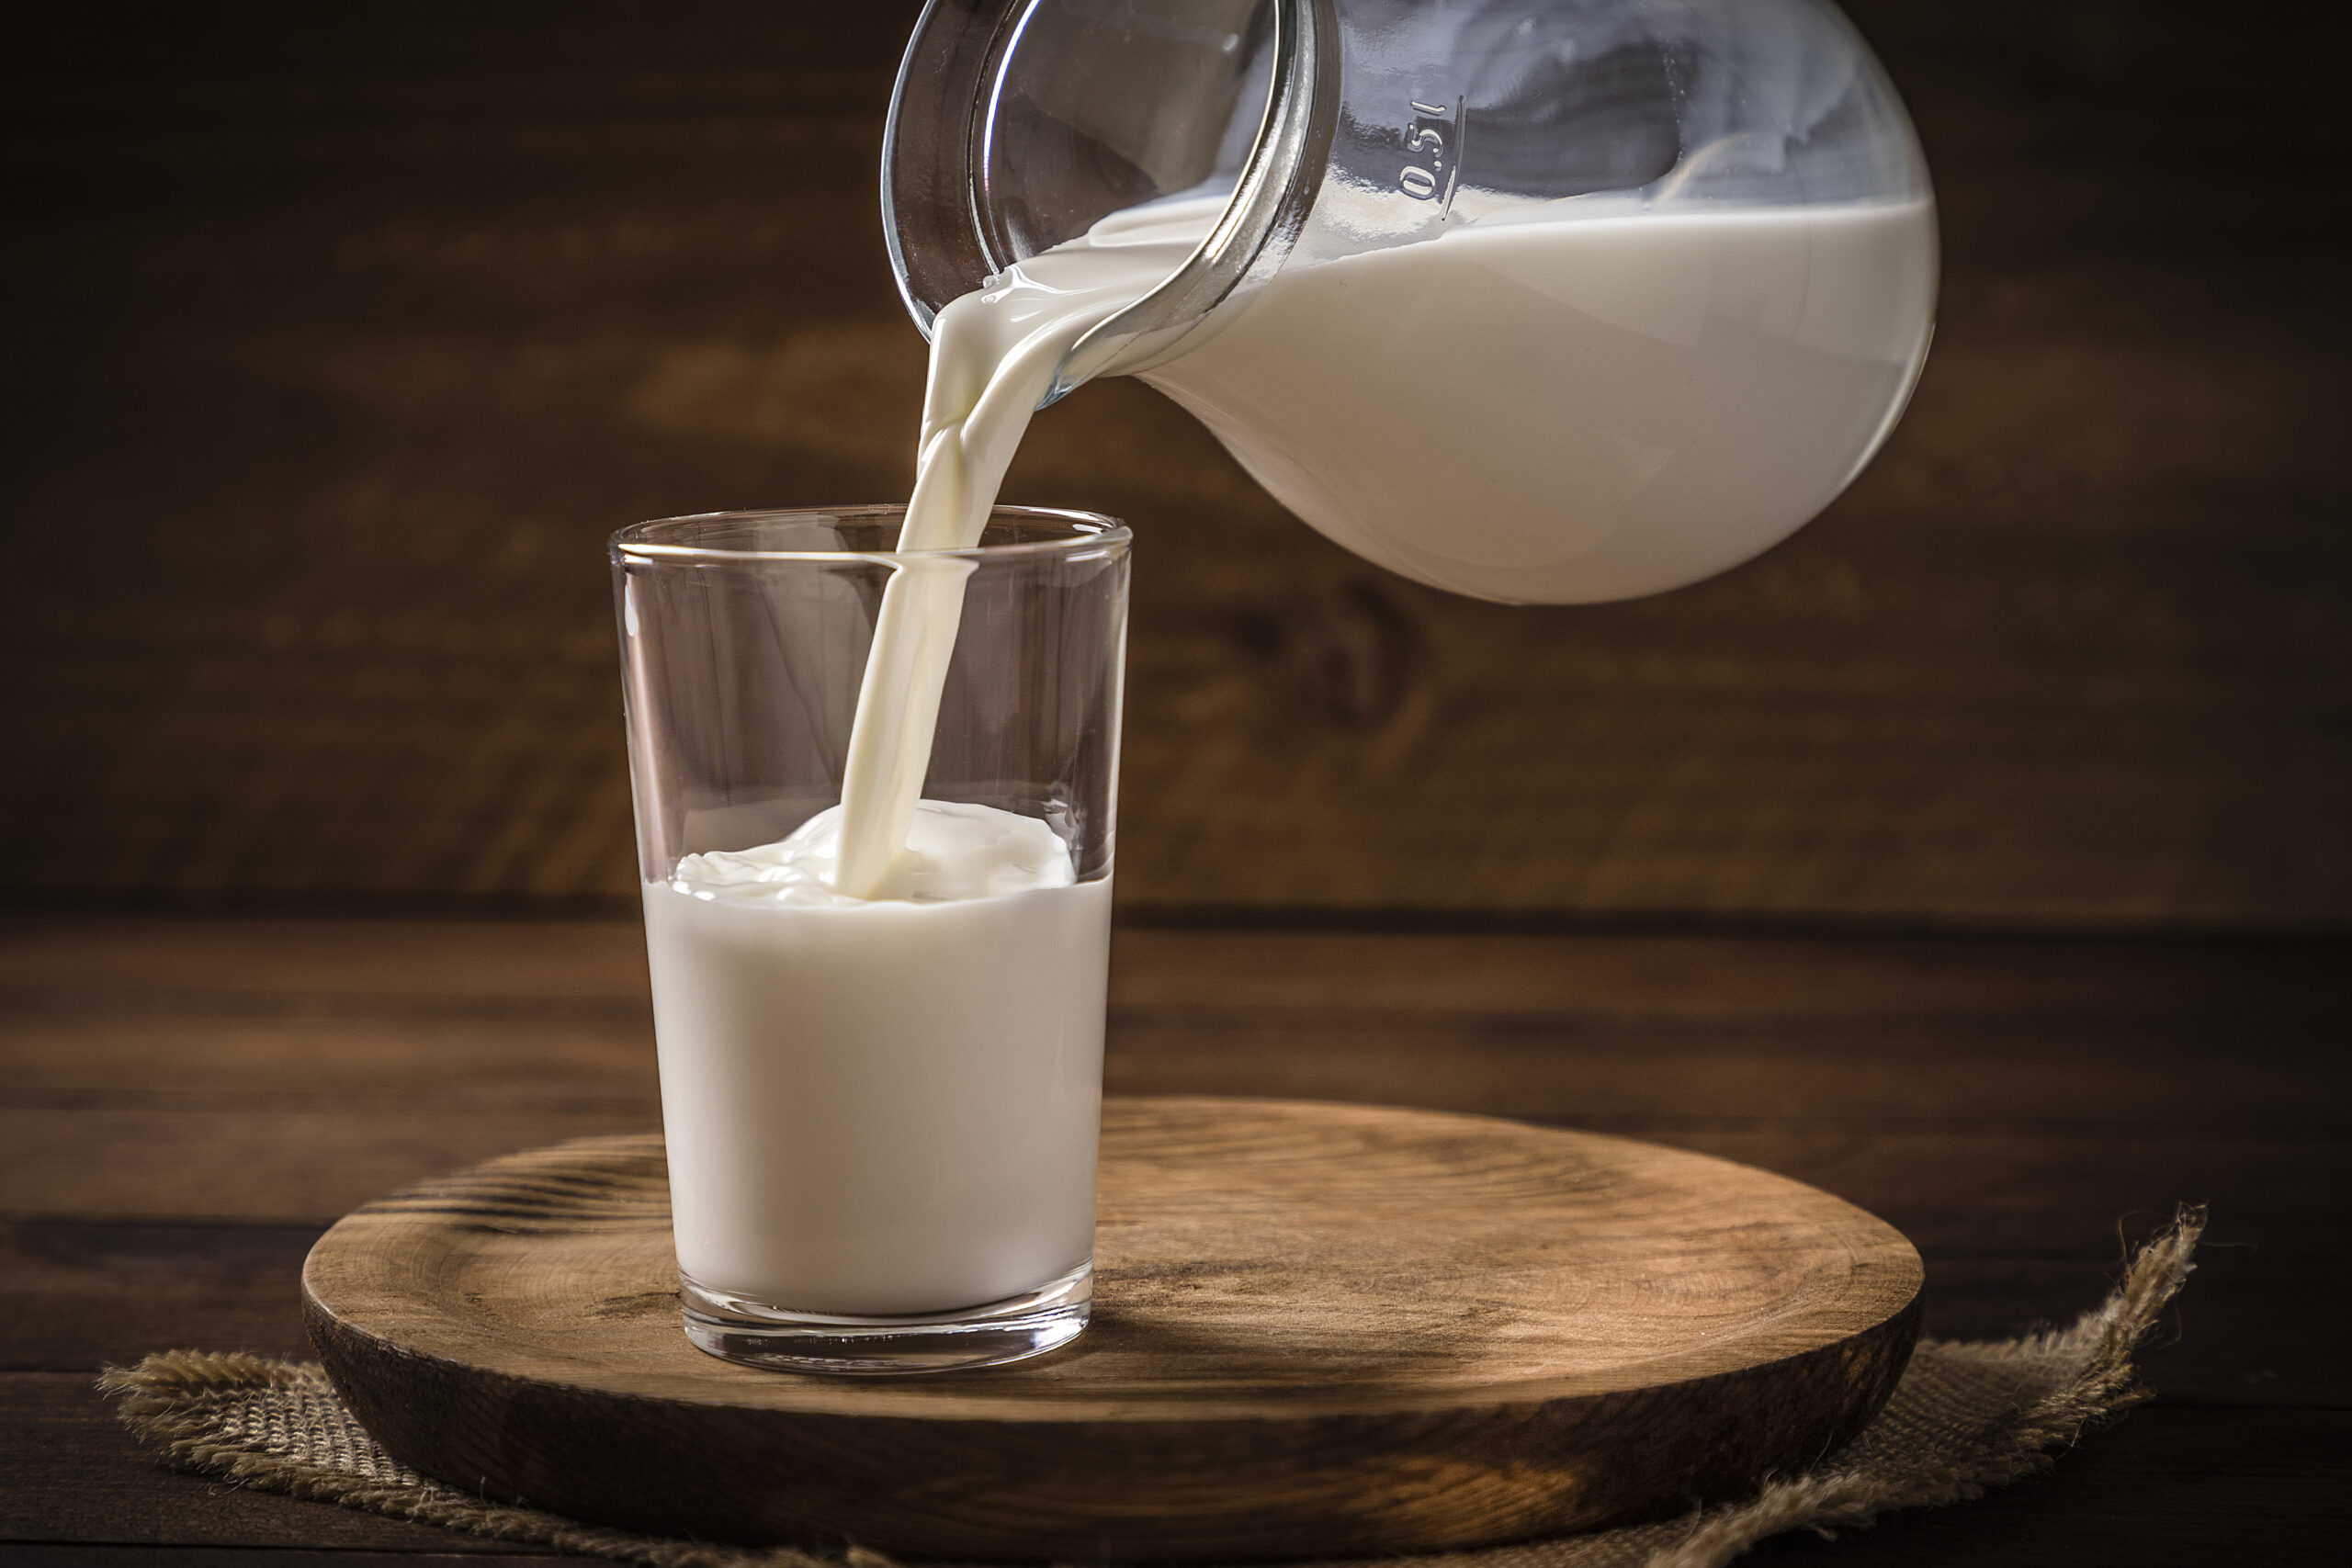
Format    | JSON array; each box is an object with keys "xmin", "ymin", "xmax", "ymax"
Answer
[{"xmin": 0, "ymin": 1009, "xmax": 2343, "ymax": 1135}]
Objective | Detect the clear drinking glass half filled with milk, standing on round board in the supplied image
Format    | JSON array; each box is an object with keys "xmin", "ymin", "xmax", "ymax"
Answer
[{"xmin": 612, "ymin": 505, "xmax": 1129, "ymax": 1373}]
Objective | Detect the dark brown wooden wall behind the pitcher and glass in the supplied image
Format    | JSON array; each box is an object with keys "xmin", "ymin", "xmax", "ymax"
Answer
[{"xmin": 0, "ymin": 0, "xmax": 2352, "ymax": 931}]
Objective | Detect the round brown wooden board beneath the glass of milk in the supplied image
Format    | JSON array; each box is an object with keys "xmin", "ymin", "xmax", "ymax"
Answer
[{"xmin": 303, "ymin": 1098, "xmax": 1919, "ymax": 1561}]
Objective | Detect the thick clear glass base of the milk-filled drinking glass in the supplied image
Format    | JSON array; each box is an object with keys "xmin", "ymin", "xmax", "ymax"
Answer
[{"xmin": 677, "ymin": 1258, "xmax": 1093, "ymax": 1378}]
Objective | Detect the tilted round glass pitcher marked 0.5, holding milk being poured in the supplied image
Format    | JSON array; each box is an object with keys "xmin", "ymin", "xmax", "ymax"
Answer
[{"xmin": 882, "ymin": 0, "xmax": 1936, "ymax": 604}]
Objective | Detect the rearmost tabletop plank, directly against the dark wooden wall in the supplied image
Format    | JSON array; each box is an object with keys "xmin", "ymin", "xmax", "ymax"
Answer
[{"xmin": 14, "ymin": 917, "xmax": 2352, "ymax": 1027}]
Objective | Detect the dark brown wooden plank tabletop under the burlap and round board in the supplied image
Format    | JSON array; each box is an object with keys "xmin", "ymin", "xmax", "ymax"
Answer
[{"xmin": 0, "ymin": 919, "xmax": 2352, "ymax": 1568}]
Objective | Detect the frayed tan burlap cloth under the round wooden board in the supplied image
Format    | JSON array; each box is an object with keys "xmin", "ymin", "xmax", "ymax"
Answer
[{"xmin": 99, "ymin": 1208, "xmax": 2204, "ymax": 1568}]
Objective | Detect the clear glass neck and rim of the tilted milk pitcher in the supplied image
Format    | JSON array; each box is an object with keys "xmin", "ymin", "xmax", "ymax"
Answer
[{"xmin": 882, "ymin": 0, "xmax": 1340, "ymax": 402}]
